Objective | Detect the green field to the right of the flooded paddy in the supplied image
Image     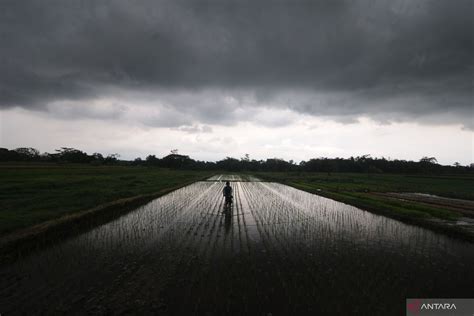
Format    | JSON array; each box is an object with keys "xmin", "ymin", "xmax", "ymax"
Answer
[{"xmin": 257, "ymin": 172, "xmax": 474, "ymax": 220}]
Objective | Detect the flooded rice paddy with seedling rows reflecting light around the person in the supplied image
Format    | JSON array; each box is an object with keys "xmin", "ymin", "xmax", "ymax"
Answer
[{"xmin": 0, "ymin": 176, "xmax": 474, "ymax": 315}]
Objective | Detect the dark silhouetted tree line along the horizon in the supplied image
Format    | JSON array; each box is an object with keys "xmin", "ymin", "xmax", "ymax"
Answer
[{"xmin": 0, "ymin": 147, "xmax": 474, "ymax": 173}]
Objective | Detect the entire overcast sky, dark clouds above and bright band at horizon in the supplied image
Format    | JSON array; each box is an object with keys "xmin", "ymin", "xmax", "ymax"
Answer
[{"xmin": 0, "ymin": 0, "xmax": 474, "ymax": 164}]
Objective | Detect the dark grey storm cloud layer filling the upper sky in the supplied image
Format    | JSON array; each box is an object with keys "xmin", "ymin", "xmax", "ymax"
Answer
[{"xmin": 0, "ymin": 0, "xmax": 474, "ymax": 127}]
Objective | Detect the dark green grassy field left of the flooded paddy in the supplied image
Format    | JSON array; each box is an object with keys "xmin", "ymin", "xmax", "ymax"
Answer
[{"xmin": 0, "ymin": 164, "xmax": 209, "ymax": 235}]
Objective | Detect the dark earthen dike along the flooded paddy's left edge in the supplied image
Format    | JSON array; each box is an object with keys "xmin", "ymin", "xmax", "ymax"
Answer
[{"xmin": 0, "ymin": 177, "xmax": 207, "ymax": 265}]
